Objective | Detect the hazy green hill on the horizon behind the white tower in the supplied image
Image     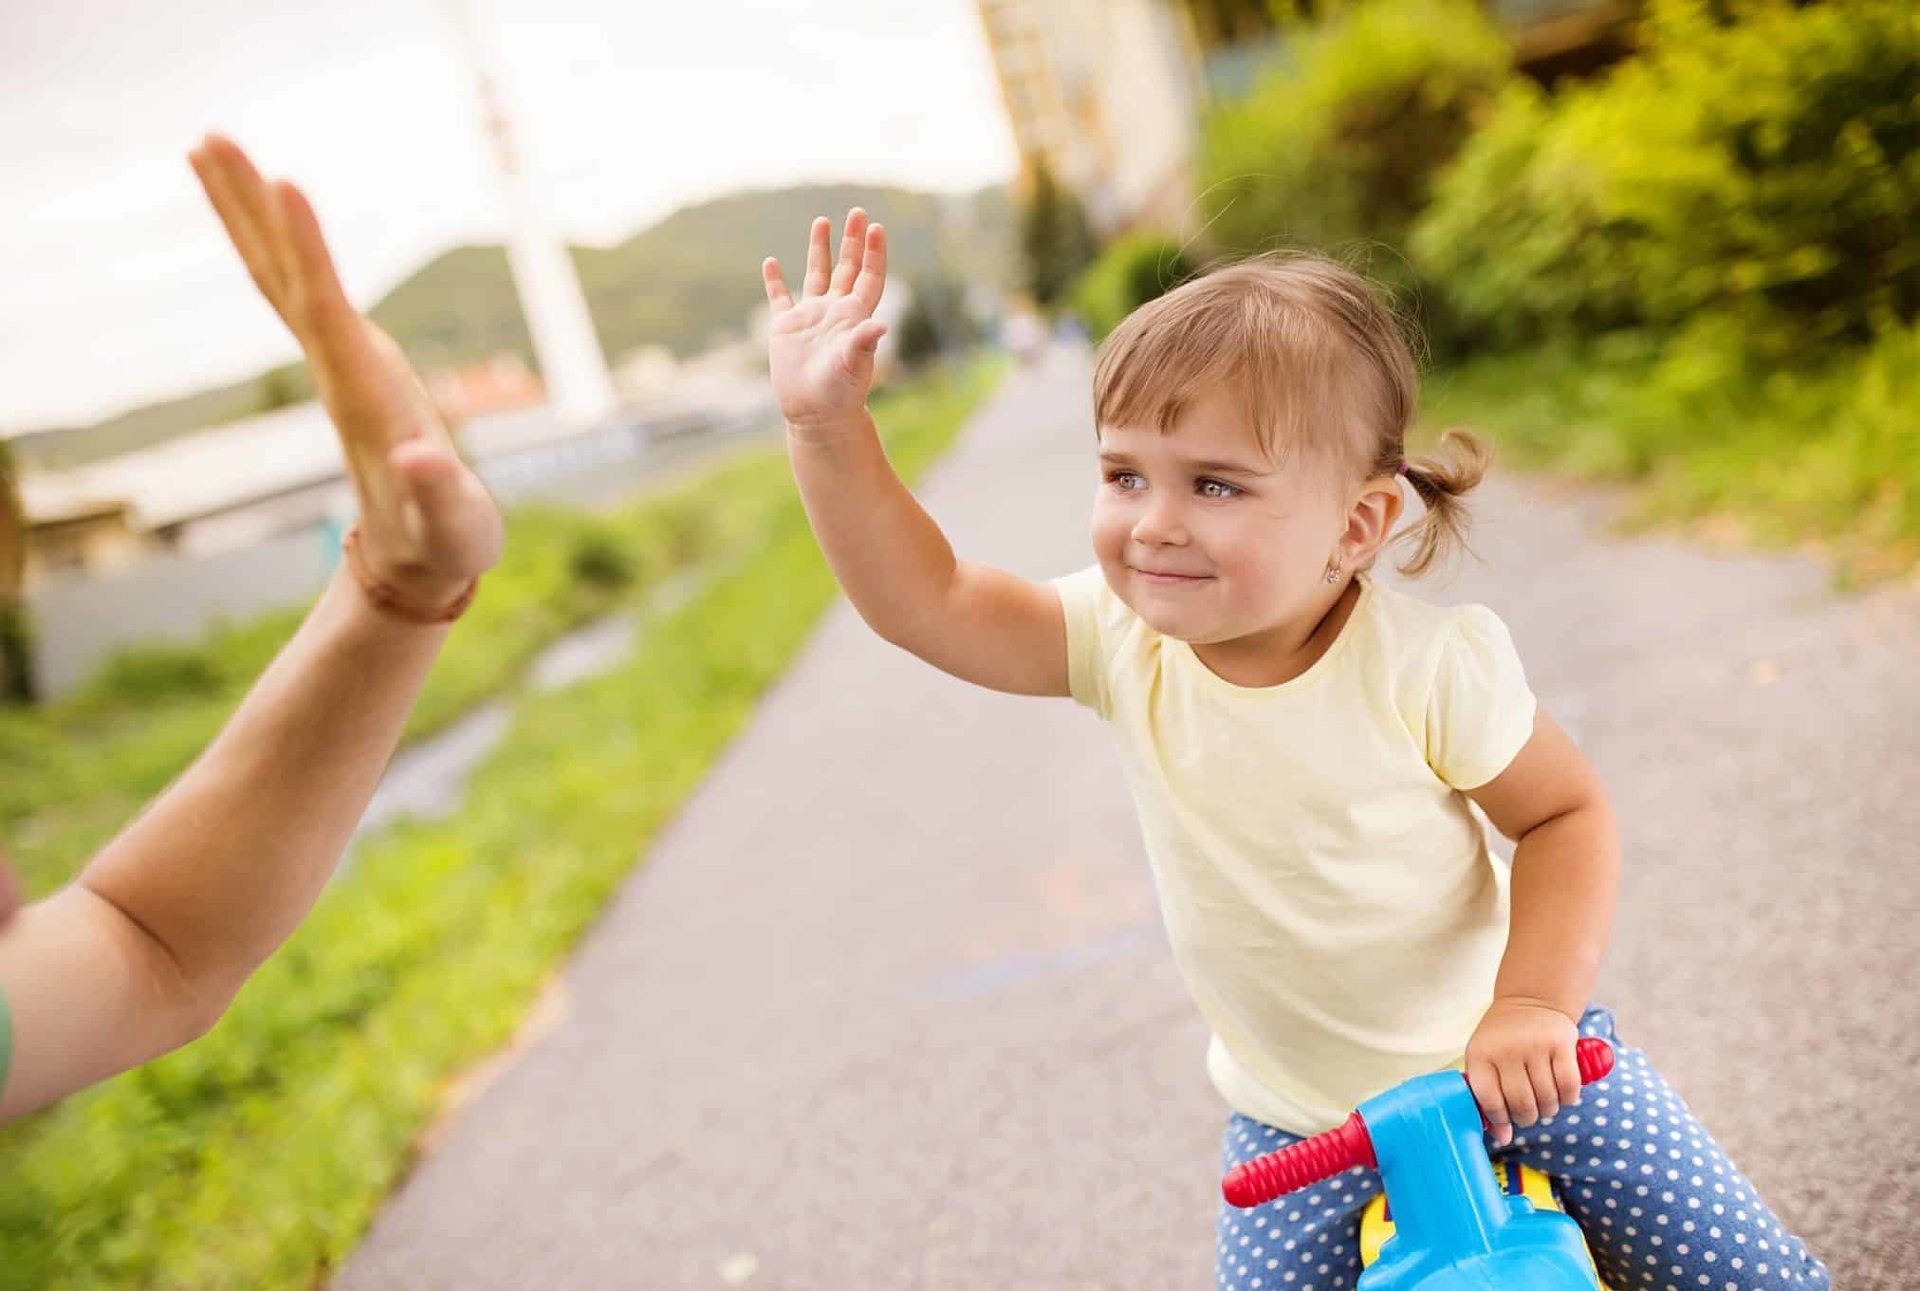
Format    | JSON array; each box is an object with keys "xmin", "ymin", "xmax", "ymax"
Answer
[{"xmin": 12, "ymin": 176, "xmax": 1016, "ymax": 469}]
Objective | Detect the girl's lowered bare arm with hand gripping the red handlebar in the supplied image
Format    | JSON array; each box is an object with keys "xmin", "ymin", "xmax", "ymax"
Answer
[{"xmin": 1467, "ymin": 713, "xmax": 1620, "ymax": 1143}]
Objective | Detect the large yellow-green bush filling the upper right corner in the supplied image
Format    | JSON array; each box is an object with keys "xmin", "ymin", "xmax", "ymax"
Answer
[{"xmin": 1413, "ymin": 0, "xmax": 1920, "ymax": 357}]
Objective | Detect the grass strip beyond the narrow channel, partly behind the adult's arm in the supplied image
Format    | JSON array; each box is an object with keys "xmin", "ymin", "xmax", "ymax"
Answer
[{"xmin": 0, "ymin": 428, "xmax": 817, "ymax": 895}]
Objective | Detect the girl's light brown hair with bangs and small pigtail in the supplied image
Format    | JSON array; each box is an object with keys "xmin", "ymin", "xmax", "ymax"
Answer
[{"xmin": 1092, "ymin": 254, "xmax": 1492, "ymax": 574}]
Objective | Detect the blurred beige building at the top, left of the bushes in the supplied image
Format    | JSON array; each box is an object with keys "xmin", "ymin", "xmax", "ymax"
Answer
[{"xmin": 977, "ymin": 0, "xmax": 1202, "ymax": 236}]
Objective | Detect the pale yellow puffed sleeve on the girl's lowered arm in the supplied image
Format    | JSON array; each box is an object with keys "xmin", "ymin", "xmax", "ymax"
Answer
[{"xmin": 1427, "ymin": 605, "xmax": 1534, "ymax": 792}]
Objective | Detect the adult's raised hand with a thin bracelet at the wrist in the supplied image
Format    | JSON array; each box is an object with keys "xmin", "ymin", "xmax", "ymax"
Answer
[{"xmin": 188, "ymin": 134, "xmax": 505, "ymax": 615}]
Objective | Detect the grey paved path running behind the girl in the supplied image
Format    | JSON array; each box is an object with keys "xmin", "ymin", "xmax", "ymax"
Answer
[{"xmin": 336, "ymin": 347, "xmax": 1920, "ymax": 1291}]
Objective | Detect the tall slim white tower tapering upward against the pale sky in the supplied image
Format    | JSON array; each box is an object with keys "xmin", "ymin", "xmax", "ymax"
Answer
[{"xmin": 447, "ymin": 0, "xmax": 614, "ymax": 423}]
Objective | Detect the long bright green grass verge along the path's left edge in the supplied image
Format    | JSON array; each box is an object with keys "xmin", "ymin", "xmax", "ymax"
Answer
[{"xmin": 0, "ymin": 369, "xmax": 991, "ymax": 1289}]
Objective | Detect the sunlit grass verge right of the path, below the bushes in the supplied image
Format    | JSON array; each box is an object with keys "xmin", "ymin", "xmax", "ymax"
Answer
[{"xmin": 1427, "ymin": 329, "xmax": 1920, "ymax": 584}]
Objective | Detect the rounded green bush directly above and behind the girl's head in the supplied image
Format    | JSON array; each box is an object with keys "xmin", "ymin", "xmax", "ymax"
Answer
[{"xmin": 1198, "ymin": 0, "xmax": 1511, "ymax": 284}]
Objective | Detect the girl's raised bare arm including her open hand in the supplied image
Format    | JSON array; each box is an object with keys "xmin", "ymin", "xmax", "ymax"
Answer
[{"xmin": 762, "ymin": 209, "xmax": 1068, "ymax": 695}]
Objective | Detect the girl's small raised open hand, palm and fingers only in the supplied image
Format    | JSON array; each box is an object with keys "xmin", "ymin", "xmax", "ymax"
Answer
[{"xmin": 760, "ymin": 207, "xmax": 887, "ymax": 438}]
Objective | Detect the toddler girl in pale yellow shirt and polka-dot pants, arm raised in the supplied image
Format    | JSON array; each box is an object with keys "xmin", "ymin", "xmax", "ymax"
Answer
[{"xmin": 762, "ymin": 211, "xmax": 1828, "ymax": 1291}]
